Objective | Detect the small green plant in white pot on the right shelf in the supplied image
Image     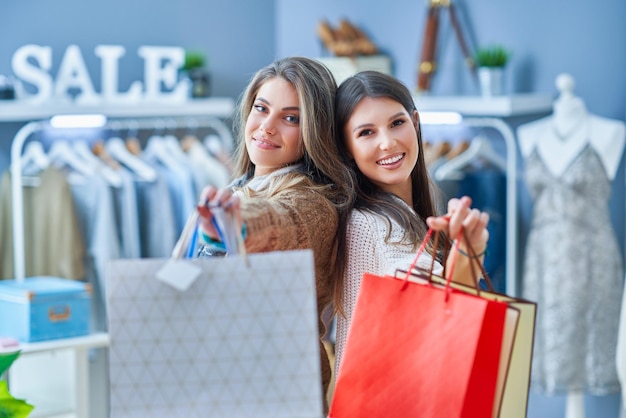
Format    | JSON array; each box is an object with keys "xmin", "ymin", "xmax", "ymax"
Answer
[{"xmin": 474, "ymin": 44, "xmax": 511, "ymax": 97}]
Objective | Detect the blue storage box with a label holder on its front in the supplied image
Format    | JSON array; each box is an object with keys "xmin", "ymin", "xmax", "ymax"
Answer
[{"xmin": 0, "ymin": 276, "xmax": 91, "ymax": 342}]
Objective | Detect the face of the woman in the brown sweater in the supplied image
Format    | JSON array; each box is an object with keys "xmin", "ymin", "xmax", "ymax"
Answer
[{"xmin": 245, "ymin": 78, "xmax": 303, "ymax": 176}]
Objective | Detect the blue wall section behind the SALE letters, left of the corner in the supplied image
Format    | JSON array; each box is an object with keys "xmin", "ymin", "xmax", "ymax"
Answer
[{"xmin": 0, "ymin": 0, "xmax": 275, "ymax": 97}]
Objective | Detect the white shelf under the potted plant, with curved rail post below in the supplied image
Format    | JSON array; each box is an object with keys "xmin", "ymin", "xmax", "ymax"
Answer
[{"xmin": 413, "ymin": 94, "xmax": 553, "ymax": 296}]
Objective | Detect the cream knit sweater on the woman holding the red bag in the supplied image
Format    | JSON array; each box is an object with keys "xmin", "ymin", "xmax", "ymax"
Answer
[{"xmin": 335, "ymin": 209, "xmax": 443, "ymax": 375}]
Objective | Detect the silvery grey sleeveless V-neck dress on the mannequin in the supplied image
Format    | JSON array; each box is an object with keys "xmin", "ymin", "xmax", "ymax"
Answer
[{"xmin": 523, "ymin": 146, "xmax": 624, "ymax": 395}]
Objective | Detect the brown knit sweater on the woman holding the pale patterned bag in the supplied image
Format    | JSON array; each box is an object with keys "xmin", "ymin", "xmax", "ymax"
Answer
[{"xmin": 241, "ymin": 186, "xmax": 338, "ymax": 404}]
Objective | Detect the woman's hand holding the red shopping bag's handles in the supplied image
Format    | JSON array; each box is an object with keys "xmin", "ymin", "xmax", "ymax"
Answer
[{"xmin": 426, "ymin": 196, "xmax": 489, "ymax": 255}]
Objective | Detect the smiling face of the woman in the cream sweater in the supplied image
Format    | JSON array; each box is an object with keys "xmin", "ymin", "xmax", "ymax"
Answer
[{"xmin": 344, "ymin": 97, "xmax": 419, "ymax": 205}]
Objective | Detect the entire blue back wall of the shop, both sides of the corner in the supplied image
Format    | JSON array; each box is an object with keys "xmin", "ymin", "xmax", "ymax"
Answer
[{"xmin": 0, "ymin": 0, "xmax": 626, "ymax": 418}]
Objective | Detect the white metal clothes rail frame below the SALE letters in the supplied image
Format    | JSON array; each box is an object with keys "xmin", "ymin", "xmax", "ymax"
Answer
[{"xmin": 10, "ymin": 116, "xmax": 234, "ymax": 282}]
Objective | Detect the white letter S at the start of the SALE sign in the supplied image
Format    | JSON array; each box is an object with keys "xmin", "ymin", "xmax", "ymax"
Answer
[{"xmin": 11, "ymin": 45, "xmax": 52, "ymax": 103}]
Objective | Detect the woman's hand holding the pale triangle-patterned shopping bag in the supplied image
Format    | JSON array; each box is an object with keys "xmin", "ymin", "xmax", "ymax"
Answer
[{"xmin": 197, "ymin": 186, "xmax": 242, "ymax": 241}]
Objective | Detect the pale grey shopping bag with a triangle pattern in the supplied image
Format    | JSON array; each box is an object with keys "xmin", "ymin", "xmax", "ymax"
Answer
[{"xmin": 107, "ymin": 250, "xmax": 323, "ymax": 418}]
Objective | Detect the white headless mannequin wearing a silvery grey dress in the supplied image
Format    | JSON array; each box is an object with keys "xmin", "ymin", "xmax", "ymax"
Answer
[{"xmin": 518, "ymin": 74, "xmax": 626, "ymax": 418}]
